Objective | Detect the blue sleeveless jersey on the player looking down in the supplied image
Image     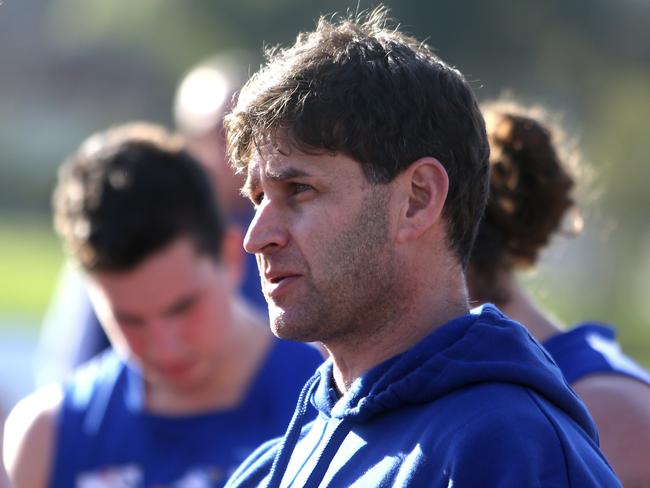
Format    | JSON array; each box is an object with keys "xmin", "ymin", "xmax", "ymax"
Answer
[{"xmin": 49, "ymin": 340, "xmax": 322, "ymax": 488}]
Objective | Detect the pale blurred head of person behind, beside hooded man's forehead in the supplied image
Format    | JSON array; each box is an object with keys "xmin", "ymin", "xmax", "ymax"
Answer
[{"xmin": 174, "ymin": 51, "xmax": 250, "ymax": 217}]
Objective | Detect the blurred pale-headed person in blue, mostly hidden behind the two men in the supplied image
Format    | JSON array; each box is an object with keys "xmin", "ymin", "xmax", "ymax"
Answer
[{"xmin": 36, "ymin": 51, "xmax": 267, "ymax": 386}]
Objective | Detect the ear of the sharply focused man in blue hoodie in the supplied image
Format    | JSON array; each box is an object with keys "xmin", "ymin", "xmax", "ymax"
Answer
[{"xmin": 397, "ymin": 157, "xmax": 449, "ymax": 242}]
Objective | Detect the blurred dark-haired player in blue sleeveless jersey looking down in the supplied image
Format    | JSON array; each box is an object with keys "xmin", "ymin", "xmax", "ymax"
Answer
[{"xmin": 4, "ymin": 124, "xmax": 321, "ymax": 488}]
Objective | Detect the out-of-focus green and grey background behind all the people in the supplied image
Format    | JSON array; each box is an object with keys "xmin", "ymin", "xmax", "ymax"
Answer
[{"xmin": 0, "ymin": 0, "xmax": 650, "ymax": 408}]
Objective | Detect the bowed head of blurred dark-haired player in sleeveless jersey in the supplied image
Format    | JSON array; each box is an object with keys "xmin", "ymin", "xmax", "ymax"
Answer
[{"xmin": 53, "ymin": 123, "xmax": 240, "ymax": 388}]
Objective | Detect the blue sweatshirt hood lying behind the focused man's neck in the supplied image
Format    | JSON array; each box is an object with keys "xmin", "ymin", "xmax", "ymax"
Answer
[{"xmin": 311, "ymin": 305, "xmax": 597, "ymax": 441}]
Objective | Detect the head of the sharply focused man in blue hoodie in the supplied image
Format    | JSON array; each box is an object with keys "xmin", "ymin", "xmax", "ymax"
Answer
[{"xmin": 226, "ymin": 9, "xmax": 488, "ymax": 342}]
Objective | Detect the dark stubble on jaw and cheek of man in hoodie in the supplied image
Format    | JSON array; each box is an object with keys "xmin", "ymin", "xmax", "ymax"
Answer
[{"xmin": 269, "ymin": 185, "xmax": 404, "ymax": 348}]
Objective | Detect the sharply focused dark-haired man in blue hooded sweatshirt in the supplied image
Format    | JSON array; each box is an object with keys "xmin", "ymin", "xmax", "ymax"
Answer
[{"xmin": 221, "ymin": 8, "xmax": 619, "ymax": 488}]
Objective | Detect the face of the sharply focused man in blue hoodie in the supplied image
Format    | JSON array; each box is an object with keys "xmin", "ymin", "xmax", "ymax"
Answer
[{"xmin": 244, "ymin": 150, "xmax": 398, "ymax": 345}]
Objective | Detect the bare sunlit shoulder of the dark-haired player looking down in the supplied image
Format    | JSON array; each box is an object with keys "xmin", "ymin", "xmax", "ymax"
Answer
[{"xmin": 3, "ymin": 385, "xmax": 63, "ymax": 488}]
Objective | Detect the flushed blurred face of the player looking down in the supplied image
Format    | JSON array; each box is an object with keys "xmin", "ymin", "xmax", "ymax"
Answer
[{"xmin": 90, "ymin": 238, "xmax": 231, "ymax": 391}]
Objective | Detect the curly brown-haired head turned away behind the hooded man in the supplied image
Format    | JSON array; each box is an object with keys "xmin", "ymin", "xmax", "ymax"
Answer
[{"xmin": 468, "ymin": 99, "xmax": 580, "ymax": 305}]
